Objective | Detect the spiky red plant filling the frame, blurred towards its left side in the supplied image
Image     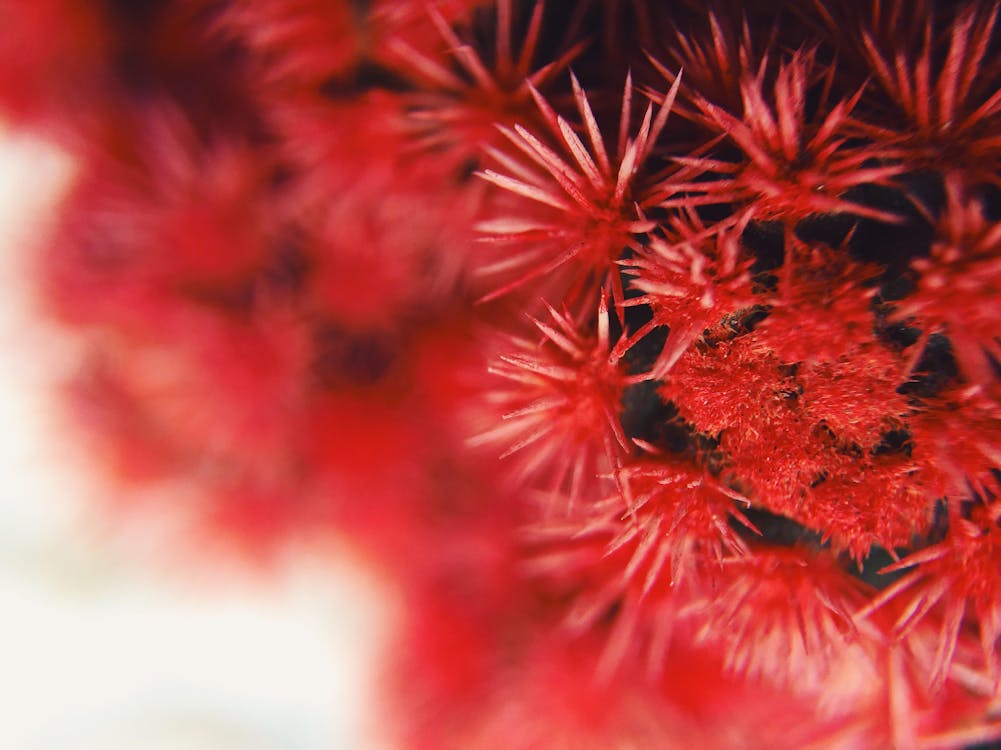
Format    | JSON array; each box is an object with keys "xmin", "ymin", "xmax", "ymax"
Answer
[{"xmin": 0, "ymin": 0, "xmax": 1001, "ymax": 750}]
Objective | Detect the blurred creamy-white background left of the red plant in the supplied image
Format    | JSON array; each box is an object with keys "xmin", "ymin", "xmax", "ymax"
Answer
[{"xmin": 0, "ymin": 129, "xmax": 391, "ymax": 750}]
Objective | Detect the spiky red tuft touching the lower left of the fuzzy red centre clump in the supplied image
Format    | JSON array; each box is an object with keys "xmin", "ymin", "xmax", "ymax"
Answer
[{"xmin": 528, "ymin": 456, "xmax": 757, "ymax": 679}]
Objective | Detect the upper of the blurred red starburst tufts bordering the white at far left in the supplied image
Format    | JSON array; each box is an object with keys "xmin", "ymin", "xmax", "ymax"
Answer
[{"xmin": 42, "ymin": 105, "xmax": 277, "ymax": 336}]
